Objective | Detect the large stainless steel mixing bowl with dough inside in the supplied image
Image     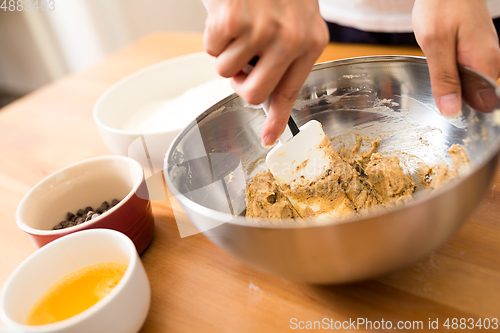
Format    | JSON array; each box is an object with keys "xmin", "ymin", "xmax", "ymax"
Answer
[{"xmin": 164, "ymin": 56, "xmax": 500, "ymax": 283}]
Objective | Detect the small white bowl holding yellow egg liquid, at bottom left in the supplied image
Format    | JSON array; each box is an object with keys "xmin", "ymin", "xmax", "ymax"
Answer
[{"xmin": 0, "ymin": 229, "xmax": 151, "ymax": 333}]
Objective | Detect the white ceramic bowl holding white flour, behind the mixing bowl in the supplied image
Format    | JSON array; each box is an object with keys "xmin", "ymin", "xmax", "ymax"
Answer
[{"xmin": 93, "ymin": 53, "xmax": 229, "ymax": 174}]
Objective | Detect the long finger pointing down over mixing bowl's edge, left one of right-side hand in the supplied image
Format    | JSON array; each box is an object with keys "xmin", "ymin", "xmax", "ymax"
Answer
[{"xmin": 421, "ymin": 35, "xmax": 462, "ymax": 117}]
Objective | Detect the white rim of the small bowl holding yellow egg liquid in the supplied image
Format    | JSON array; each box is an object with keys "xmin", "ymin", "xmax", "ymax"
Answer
[{"xmin": 0, "ymin": 229, "xmax": 139, "ymax": 333}]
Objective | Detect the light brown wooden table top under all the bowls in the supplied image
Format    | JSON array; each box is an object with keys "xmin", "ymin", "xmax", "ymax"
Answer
[{"xmin": 0, "ymin": 33, "xmax": 500, "ymax": 332}]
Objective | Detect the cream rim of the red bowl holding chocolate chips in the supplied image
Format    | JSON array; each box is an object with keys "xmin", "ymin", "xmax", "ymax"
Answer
[{"xmin": 16, "ymin": 155, "xmax": 144, "ymax": 236}]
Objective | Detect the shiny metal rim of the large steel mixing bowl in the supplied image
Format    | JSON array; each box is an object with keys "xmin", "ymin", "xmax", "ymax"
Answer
[{"xmin": 164, "ymin": 55, "xmax": 500, "ymax": 229}]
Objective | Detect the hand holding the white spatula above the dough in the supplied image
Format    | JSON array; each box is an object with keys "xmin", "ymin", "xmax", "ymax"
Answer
[{"xmin": 203, "ymin": 0, "xmax": 328, "ymax": 146}]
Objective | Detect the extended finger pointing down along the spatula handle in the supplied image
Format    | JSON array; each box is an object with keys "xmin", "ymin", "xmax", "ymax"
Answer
[{"xmin": 261, "ymin": 56, "xmax": 316, "ymax": 146}]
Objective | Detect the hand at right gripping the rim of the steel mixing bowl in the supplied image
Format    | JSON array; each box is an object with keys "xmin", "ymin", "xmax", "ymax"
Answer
[{"xmin": 412, "ymin": 0, "xmax": 500, "ymax": 117}]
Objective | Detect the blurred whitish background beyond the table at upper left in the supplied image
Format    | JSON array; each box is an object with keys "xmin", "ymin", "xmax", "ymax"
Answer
[{"xmin": 0, "ymin": 0, "xmax": 206, "ymax": 95}]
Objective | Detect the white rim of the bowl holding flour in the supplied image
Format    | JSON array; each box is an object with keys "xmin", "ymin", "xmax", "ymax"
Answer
[{"xmin": 92, "ymin": 52, "xmax": 220, "ymax": 136}]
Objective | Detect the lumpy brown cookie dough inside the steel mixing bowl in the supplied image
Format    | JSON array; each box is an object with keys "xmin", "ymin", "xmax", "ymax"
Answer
[{"xmin": 246, "ymin": 136, "xmax": 469, "ymax": 220}]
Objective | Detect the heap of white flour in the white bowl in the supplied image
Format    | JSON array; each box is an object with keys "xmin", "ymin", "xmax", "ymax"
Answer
[{"xmin": 122, "ymin": 78, "xmax": 234, "ymax": 133}]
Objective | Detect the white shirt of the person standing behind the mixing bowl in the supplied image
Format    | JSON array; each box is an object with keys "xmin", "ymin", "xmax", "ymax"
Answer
[{"xmin": 319, "ymin": 0, "xmax": 500, "ymax": 32}]
